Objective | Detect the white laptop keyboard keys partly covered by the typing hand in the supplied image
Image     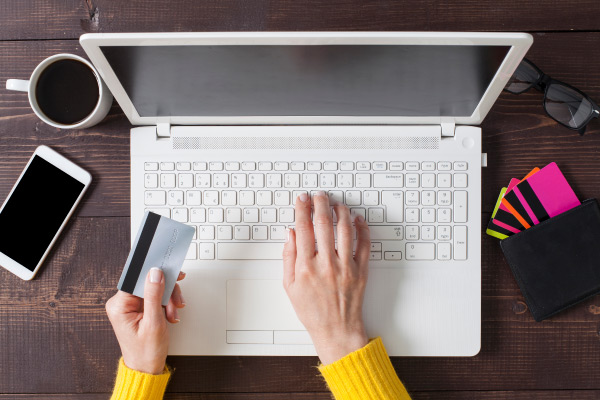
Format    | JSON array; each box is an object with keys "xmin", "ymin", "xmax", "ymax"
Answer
[{"xmin": 144, "ymin": 161, "xmax": 468, "ymax": 261}]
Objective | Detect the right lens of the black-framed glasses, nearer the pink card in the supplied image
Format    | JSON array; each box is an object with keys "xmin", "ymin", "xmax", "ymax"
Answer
[{"xmin": 544, "ymin": 83, "xmax": 594, "ymax": 129}]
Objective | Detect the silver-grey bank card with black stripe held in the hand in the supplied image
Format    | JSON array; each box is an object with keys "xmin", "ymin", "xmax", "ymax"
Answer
[{"xmin": 117, "ymin": 211, "xmax": 194, "ymax": 306}]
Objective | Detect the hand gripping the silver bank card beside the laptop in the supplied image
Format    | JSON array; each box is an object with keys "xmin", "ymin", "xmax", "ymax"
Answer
[{"xmin": 106, "ymin": 268, "xmax": 185, "ymax": 375}]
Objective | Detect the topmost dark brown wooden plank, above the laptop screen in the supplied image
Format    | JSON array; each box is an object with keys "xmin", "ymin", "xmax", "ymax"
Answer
[{"xmin": 0, "ymin": 0, "xmax": 600, "ymax": 40}]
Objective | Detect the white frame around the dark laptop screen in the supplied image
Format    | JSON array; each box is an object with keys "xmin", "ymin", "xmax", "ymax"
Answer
[{"xmin": 80, "ymin": 32, "xmax": 533, "ymax": 125}]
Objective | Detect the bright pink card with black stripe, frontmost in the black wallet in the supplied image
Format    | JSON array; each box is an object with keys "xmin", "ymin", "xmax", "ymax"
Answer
[{"xmin": 504, "ymin": 163, "xmax": 581, "ymax": 225}]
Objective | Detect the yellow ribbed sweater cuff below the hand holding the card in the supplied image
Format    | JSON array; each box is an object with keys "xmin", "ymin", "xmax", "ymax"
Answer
[{"xmin": 110, "ymin": 358, "xmax": 171, "ymax": 400}]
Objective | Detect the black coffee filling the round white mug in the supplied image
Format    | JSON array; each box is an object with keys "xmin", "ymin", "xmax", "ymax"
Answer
[{"xmin": 35, "ymin": 60, "xmax": 100, "ymax": 125}]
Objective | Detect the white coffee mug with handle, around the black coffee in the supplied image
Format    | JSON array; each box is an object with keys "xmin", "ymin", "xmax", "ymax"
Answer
[{"xmin": 6, "ymin": 54, "xmax": 113, "ymax": 129}]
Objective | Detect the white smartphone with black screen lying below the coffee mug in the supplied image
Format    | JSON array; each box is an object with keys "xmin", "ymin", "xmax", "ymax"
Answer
[{"xmin": 0, "ymin": 146, "xmax": 92, "ymax": 280}]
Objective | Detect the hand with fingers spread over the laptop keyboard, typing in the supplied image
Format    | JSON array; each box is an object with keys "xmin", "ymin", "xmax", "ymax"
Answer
[{"xmin": 283, "ymin": 192, "xmax": 371, "ymax": 365}]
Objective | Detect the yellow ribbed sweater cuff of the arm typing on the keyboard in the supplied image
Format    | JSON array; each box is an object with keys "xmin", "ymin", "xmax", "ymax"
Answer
[{"xmin": 319, "ymin": 338, "xmax": 410, "ymax": 400}]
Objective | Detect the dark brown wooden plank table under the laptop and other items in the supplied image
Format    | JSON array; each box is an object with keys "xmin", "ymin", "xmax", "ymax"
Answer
[{"xmin": 0, "ymin": 0, "xmax": 600, "ymax": 400}]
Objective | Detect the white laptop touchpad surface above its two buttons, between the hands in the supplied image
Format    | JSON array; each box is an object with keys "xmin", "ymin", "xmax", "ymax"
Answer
[{"xmin": 227, "ymin": 279, "xmax": 304, "ymax": 331}]
